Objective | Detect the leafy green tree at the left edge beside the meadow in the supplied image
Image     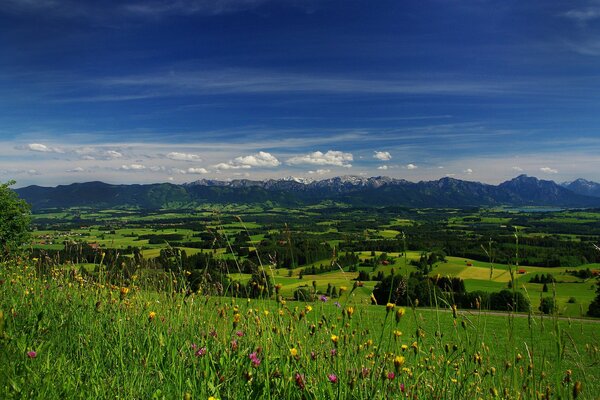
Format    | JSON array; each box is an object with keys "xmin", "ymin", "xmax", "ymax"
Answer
[{"xmin": 0, "ymin": 181, "xmax": 31, "ymax": 258}]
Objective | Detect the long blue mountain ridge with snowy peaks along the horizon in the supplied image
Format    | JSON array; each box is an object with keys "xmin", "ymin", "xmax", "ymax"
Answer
[{"xmin": 16, "ymin": 175, "xmax": 600, "ymax": 210}]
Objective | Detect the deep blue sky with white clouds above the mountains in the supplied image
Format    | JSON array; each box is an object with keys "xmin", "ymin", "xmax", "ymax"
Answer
[{"xmin": 0, "ymin": 0, "xmax": 600, "ymax": 187}]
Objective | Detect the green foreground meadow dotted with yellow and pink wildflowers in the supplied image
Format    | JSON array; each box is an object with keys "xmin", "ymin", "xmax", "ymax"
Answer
[{"xmin": 0, "ymin": 262, "xmax": 600, "ymax": 399}]
